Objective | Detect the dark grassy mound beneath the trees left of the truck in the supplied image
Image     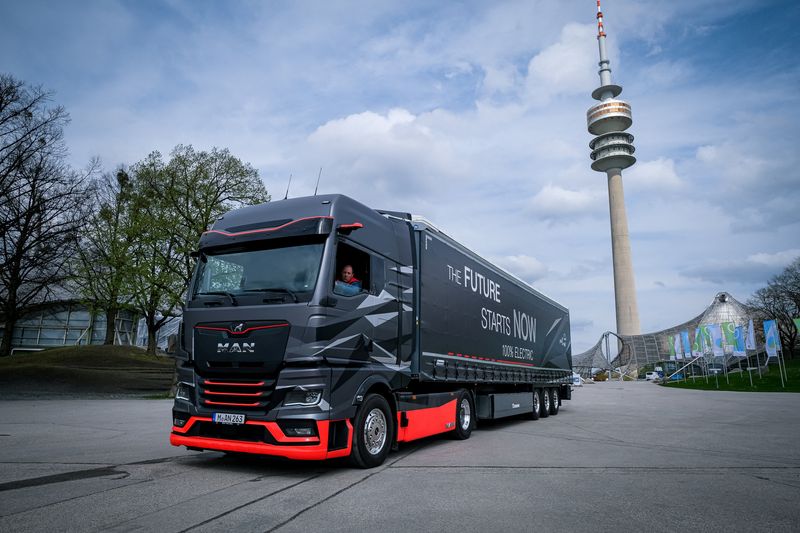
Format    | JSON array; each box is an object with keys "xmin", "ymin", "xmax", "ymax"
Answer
[{"xmin": 0, "ymin": 346, "xmax": 175, "ymax": 399}]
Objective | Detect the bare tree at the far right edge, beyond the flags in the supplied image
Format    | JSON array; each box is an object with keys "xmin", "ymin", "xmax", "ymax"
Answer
[{"xmin": 747, "ymin": 257, "xmax": 800, "ymax": 358}]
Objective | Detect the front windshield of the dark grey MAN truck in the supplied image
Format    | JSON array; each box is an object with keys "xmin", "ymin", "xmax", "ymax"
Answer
[{"xmin": 192, "ymin": 243, "xmax": 325, "ymax": 305}]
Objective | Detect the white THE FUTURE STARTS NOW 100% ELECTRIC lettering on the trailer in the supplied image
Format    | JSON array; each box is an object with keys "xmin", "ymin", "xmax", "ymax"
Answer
[{"xmin": 447, "ymin": 265, "xmax": 536, "ymax": 344}]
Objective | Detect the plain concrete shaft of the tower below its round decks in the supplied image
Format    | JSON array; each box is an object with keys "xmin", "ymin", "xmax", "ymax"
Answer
[{"xmin": 606, "ymin": 168, "xmax": 641, "ymax": 335}]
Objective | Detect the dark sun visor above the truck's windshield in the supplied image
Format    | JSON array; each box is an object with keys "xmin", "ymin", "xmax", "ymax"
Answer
[{"xmin": 200, "ymin": 216, "xmax": 333, "ymax": 249}]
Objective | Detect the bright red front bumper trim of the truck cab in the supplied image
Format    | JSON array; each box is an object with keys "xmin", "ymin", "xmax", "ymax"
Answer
[{"xmin": 169, "ymin": 416, "xmax": 353, "ymax": 460}]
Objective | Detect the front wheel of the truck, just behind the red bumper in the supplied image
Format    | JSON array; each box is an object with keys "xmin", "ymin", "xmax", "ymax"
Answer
[{"xmin": 350, "ymin": 394, "xmax": 394, "ymax": 468}]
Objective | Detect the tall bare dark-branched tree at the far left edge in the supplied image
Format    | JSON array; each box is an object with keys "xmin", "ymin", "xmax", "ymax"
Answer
[{"xmin": 0, "ymin": 75, "xmax": 94, "ymax": 355}]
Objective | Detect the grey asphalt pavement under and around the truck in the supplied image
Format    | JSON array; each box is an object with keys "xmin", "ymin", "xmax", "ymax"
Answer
[{"xmin": 0, "ymin": 382, "xmax": 800, "ymax": 532}]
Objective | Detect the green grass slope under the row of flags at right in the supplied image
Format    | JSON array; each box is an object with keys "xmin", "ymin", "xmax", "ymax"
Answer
[{"xmin": 662, "ymin": 359, "xmax": 800, "ymax": 392}]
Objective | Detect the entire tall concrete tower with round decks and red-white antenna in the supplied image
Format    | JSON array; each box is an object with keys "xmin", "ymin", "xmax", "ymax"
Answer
[{"xmin": 586, "ymin": 0, "xmax": 640, "ymax": 335}]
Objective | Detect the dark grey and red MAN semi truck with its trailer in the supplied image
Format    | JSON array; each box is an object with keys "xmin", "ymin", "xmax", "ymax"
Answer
[{"xmin": 170, "ymin": 195, "xmax": 572, "ymax": 468}]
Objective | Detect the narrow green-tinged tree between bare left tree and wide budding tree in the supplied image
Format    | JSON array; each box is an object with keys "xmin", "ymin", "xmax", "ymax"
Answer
[{"xmin": 73, "ymin": 169, "xmax": 138, "ymax": 344}]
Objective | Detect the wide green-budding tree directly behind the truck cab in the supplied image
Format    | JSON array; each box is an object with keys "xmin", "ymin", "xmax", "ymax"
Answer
[{"xmin": 133, "ymin": 145, "xmax": 269, "ymax": 353}]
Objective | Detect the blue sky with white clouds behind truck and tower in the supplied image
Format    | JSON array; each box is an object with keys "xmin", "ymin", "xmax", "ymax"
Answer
[{"xmin": 0, "ymin": 0, "xmax": 800, "ymax": 353}]
